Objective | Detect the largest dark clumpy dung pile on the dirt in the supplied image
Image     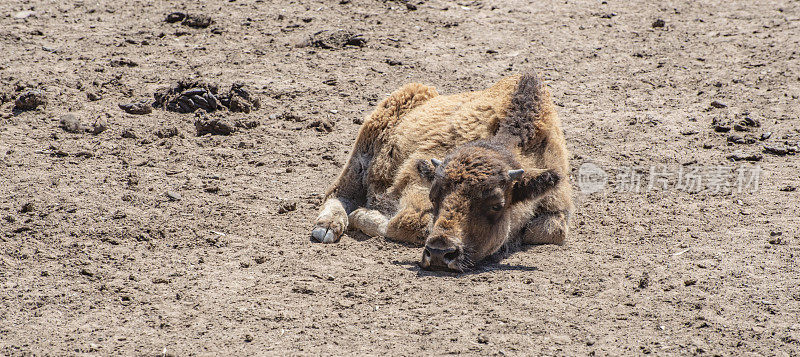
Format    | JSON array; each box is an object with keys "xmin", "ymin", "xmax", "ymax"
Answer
[{"xmin": 153, "ymin": 80, "xmax": 261, "ymax": 113}]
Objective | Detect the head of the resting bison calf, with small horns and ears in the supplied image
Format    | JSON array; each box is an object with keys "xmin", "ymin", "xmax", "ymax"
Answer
[{"xmin": 417, "ymin": 141, "xmax": 560, "ymax": 271}]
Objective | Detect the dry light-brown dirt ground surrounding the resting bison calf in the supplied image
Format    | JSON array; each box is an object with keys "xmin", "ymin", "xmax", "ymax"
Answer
[{"xmin": 0, "ymin": 0, "xmax": 800, "ymax": 356}]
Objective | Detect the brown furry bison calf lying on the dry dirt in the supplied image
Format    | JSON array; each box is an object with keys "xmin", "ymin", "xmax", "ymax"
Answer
[{"xmin": 311, "ymin": 75, "xmax": 573, "ymax": 271}]
